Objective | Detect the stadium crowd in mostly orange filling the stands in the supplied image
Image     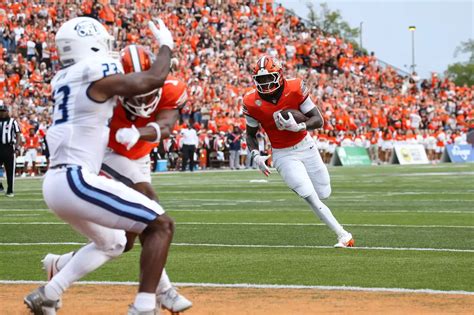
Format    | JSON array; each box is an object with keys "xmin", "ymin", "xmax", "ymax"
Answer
[{"xmin": 0, "ymin": 0, "xmax": 474, "ymax": 177}]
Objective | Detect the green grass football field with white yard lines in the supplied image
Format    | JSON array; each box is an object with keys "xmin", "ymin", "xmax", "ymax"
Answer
[{"xmin": 0, "ymin": 164, "xmax": 474, "ymax": 292}]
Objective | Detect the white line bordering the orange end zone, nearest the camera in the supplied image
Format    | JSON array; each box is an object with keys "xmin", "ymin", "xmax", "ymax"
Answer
[{"xmin": 0, "ymin": 280, "xmax": 474, "ymax": 295}]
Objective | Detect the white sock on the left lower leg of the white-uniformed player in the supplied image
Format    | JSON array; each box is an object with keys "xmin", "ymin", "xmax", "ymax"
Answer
[{"xmin": 45, "ymin": 243, "xmax": 112, "ymax": 301}]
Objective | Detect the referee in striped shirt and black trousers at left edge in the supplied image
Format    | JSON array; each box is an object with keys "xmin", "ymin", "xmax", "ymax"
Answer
[{"xmin": 0, "ymin": 104, "xmax": 21, "ymax": 197}]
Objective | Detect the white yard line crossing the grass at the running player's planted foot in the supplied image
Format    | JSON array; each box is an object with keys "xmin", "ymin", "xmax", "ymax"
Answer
[{"xmin": 0, "ymin": 242, "xmax": 474, "ymax": 253}]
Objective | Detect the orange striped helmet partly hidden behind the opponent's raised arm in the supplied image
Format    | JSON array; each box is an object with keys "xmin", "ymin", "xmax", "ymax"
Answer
[{"xmin": 120, "ymin": 45, "xmax": 161, "ymax": 118}]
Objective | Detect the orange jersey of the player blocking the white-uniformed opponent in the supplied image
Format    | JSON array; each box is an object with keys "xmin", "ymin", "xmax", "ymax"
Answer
[{"xmin": 108, "ymin": 76, "xmax": 187, "ymax": 160}]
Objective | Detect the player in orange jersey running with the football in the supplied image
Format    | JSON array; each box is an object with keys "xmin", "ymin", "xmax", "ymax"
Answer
[{"xmin": 244, "ymin": 56, "xmax": 354, "ymax": 247}]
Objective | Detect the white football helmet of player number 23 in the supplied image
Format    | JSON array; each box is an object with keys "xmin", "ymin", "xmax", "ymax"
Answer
[{"xmin": 56, "ymin": 17, "xmax": 114, "ymax": 67}]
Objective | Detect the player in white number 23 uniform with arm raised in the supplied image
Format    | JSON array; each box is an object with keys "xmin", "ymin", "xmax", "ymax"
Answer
[{"xmin": 24, "ymin": 17, "xmax": 174, "ymax": 314}]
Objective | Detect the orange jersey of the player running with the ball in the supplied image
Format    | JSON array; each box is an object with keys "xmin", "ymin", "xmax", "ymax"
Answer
[{"xmin": 243, "ymin": 79, "xmax": 309, "ymax": 149}]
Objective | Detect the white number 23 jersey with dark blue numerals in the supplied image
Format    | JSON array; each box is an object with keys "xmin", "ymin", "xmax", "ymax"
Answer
[{"xmin": 46, "ymin": 57, "xmax": 123, "ymax": 174}]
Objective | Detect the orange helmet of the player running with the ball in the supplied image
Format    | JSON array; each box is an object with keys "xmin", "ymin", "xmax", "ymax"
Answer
[{"xmin": 252, "ymin": 56, "xmax": 283, "ymax": 94}]
